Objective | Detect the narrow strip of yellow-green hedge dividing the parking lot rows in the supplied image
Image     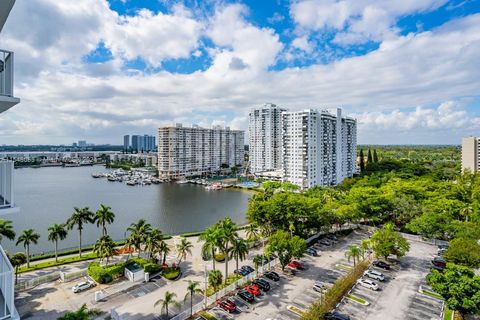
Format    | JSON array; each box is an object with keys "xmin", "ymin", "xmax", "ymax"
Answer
[{"xmin": 301, "ymin": 260, "xmax": 370, "ymax": 320}]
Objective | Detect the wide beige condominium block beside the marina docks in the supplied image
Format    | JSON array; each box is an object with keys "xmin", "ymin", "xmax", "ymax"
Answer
[{"xmin": 158, "ymin": 123, "xmax": 245, "ymax": 179}]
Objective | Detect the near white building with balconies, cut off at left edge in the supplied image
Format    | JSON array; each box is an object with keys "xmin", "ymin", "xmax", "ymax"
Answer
[{"xmin": 0, "ymin": 0, "xmax": 20, "ymax": 320}]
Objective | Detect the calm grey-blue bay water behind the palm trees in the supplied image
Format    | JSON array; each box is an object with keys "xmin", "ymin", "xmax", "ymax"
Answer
[{"xmin": 2, "ymin": 166, "xmax": 250, "ymax": 253}]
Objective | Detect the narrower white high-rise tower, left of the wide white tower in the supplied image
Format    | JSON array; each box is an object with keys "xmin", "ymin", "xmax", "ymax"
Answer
[{"xmin": 248, "ymin": 103, "xmax": 286, "ymax": 173}]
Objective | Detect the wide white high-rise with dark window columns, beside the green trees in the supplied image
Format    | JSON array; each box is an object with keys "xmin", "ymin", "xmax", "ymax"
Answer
[{"xmin": 282, "ymin": 109, "xmax": 357, "ymax": 189}]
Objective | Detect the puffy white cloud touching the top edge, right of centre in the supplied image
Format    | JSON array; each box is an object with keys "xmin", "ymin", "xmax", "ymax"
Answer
[{"xmin": 290, "ymin": 0, "xmax": 447, "ymax": 44}]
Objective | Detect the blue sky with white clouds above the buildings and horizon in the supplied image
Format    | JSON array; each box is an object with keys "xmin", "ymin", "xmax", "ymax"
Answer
[{"xmin": 0, "ymin": 0, "xmax": 480, "ymax": 145}]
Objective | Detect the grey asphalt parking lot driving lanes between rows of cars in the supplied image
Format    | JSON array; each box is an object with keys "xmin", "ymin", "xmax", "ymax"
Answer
[{"xmin": 209, "ymin": 231, "xmax": 443, "ymax": 320}]
